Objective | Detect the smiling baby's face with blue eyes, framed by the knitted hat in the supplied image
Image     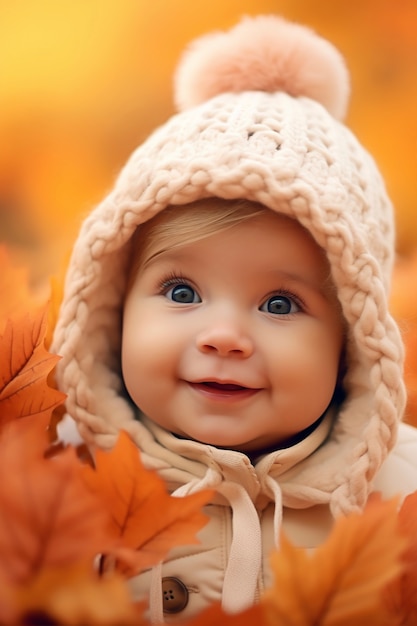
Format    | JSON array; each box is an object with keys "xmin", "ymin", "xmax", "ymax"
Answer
[{"xmin": 122, "ymin": 211, "xmax": 343, "ymax": 453}]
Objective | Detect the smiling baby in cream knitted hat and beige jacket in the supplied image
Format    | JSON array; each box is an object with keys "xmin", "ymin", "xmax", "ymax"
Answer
[{"xmin": 53, "ymin": 16, "xmax": 417, "ymax": 622}]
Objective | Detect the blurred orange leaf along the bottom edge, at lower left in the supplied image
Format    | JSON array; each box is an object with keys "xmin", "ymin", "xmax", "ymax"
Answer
[{"xmin": 8, "ymin": 564, "xmax": 148, "ymax": 626}]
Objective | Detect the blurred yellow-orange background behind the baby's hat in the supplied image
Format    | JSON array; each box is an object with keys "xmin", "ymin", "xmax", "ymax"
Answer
[{"xmin": 0, "ymin": 0, "xmax": 417, "ymax": 424}]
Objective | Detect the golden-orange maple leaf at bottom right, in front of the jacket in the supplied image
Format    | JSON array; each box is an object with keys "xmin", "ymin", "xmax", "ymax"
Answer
[{"xmin": 262, "ymin": 499, "xmax": 405, "ymax": 626}]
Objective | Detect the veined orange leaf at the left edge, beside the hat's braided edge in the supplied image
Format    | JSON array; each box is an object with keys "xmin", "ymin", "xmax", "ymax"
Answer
[{"xmin": 0, "ymin": 306, "xmax": 65, "ymax": 425}]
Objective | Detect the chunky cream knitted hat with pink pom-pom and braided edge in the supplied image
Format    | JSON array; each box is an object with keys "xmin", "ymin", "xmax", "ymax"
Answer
[{"xmin": 52, "ymin": 16, "xmax": 405, "ymax": 512}]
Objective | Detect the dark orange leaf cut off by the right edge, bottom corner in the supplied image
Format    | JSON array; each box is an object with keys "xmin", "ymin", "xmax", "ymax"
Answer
[{"xmin": 383, "ymin": 492, "xmax": 417, "ymax": 626}]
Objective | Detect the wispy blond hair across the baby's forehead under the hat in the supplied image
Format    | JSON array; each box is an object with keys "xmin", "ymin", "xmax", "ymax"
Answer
[{"xmin": 127, "ymin": 198, "xmax": 266, "ymax": 292}]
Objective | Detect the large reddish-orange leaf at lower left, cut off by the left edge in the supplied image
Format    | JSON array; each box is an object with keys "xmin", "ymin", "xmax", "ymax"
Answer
[{"xmin": 0, "ymin": 436, "xmax": 114, "ymax": 584}]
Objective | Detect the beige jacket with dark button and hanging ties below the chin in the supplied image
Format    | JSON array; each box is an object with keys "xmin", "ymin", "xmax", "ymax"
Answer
[{"xmin": 130, "ymin": 415, "xmax": 417, "ymax": 622}]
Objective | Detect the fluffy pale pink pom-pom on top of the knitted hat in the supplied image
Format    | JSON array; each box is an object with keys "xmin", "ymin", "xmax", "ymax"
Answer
[{"xmin": 175, "ymin": 15, "xmax": 349, "ymax": 119}]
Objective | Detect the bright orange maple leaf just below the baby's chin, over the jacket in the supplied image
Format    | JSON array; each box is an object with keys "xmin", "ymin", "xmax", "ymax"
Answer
[{"xmin": 84, "ymin": 431, "xmax": 213, "ymax": 574}]
